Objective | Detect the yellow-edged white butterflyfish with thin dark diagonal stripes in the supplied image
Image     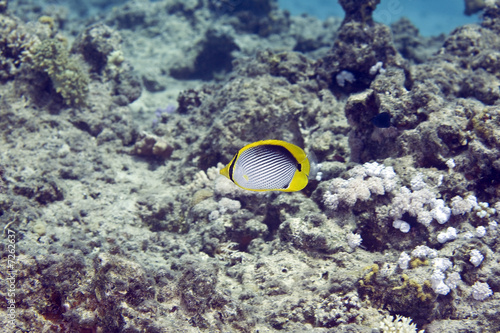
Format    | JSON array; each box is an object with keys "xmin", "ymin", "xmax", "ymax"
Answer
[{"xmin": 220, "ymin": 140, "xmax": 310, "ymax": 192}]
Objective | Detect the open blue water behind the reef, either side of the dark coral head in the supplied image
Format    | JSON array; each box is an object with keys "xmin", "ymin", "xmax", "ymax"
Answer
[{"xmin": 278, "ymin": 0, "xmax": 479, "ymax": 36}]
